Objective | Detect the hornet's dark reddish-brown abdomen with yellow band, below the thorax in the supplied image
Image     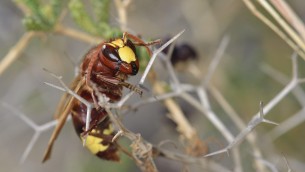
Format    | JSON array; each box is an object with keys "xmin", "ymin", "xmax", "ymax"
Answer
[{"xmin": 72, "ymin": 86, "xmax": 120, "ymax": 161}]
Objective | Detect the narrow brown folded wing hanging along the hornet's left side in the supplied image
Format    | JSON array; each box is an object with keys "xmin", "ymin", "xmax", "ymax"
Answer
[{"xmin": 42, "ymin": 76, "xmax": 85, "ymax": 162}]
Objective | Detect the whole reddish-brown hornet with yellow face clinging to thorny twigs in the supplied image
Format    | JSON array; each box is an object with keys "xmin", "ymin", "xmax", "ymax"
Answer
[{"xmin": 43, "ymin": 32, "xmax": 159, "ymax": 162}]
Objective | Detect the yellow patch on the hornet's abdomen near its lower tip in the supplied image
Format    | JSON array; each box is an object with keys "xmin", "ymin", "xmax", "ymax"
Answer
[{"xmin": 83, "ymin": 135, "xmax": 109, "ymax": 154}]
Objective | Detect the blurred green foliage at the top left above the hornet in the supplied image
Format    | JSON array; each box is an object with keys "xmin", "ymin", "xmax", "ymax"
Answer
[{"xmin": 15, "ymin": 0, "xmax": 122, "ymax": 39}]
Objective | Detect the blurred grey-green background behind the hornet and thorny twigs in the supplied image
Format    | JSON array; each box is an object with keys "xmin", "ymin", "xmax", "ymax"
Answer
[{"xmin": 0, "ymin": 0, "xmax": 305, "ymax": 172}]
